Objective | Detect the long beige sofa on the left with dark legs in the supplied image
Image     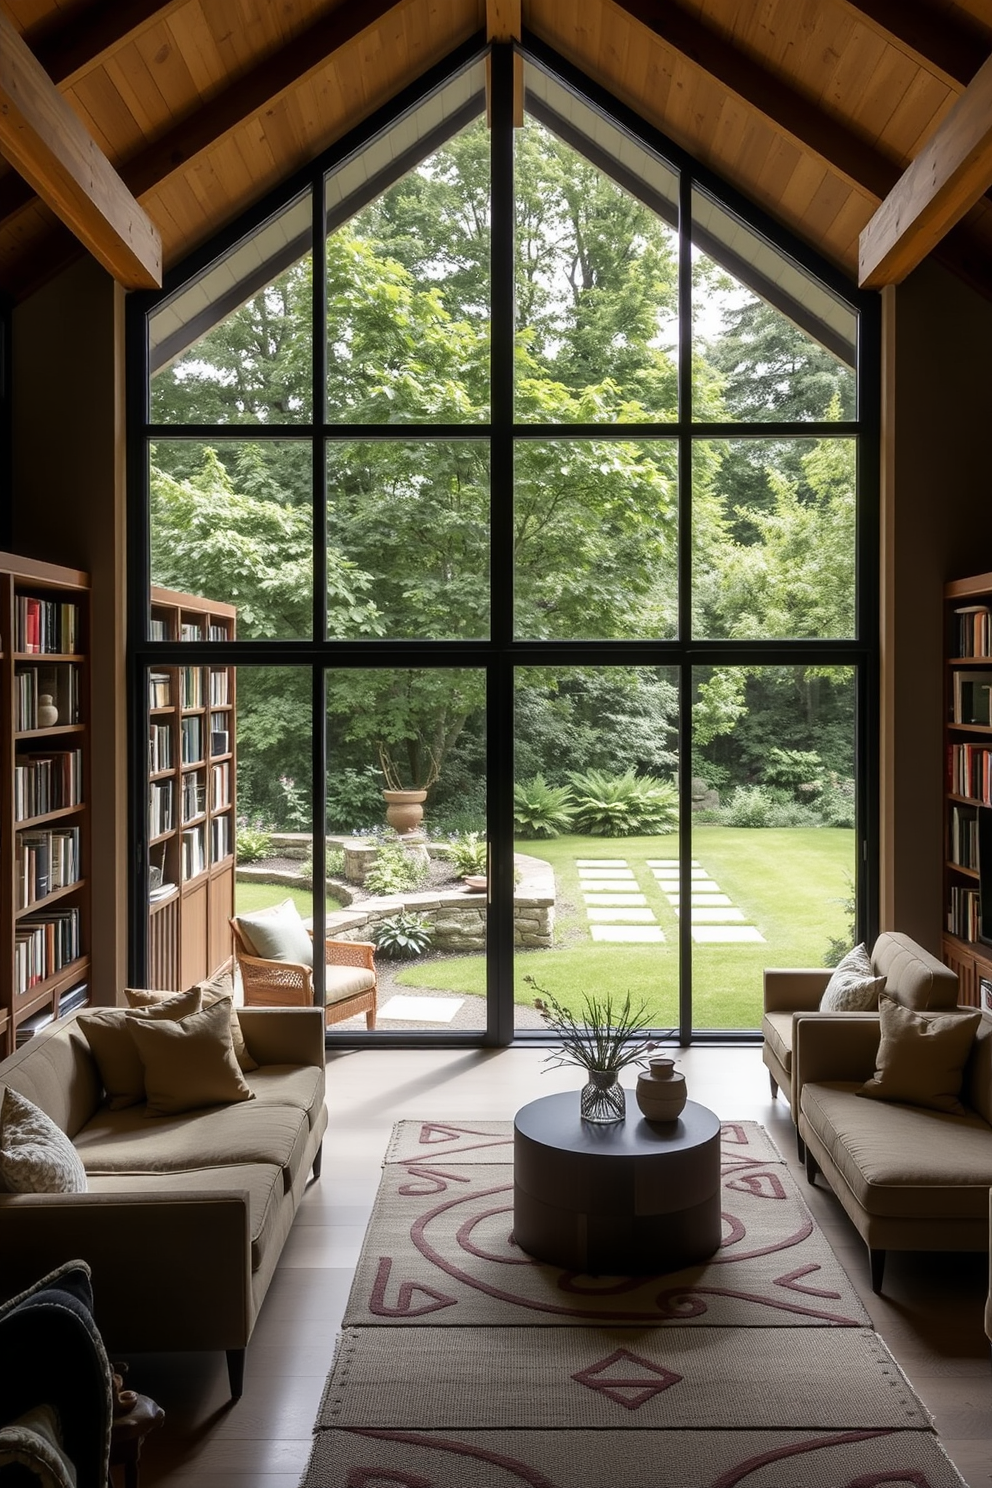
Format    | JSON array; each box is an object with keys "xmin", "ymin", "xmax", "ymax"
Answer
[{"xmin": 0, "ymin": 1007, "xmax": 327, "ymax": 1396}]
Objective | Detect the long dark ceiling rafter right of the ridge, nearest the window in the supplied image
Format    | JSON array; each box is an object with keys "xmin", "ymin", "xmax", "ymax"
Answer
[{"xmin": 613, "ymin": 0, "xmax": 898, "ymax": 201}]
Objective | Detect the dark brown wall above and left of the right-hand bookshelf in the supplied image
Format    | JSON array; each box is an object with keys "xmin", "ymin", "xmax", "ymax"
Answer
[{"xmin": 880, "ymin": 263, "xmax": 992, "ymax": 952}]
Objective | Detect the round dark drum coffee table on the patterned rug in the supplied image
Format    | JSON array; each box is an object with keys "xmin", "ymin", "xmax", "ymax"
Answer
[{"xmin": 513, "ymin": 1091, "xmax": 723, "ymax": 1275}]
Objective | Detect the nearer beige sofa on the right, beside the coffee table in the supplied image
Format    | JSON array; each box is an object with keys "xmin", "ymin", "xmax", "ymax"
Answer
[{"xmin": 793, "ymin": 1009, "xmax": 992, "ymax": 1292}]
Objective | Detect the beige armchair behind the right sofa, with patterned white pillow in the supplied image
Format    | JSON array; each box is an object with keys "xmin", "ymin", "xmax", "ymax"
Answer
[{"xmin": 761, "ymin": 930, "xmax": 958, "ymax": 1124}]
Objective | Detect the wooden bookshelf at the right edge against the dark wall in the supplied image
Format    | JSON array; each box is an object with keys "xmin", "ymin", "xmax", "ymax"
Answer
[{"xmin": 941, "ymin": 573, "xmax": 992, "ymax": 1010}]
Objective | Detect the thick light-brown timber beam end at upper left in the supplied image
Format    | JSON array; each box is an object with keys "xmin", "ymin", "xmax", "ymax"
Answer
[{"xmin": 0, "ymin": 10, "xmax": 162, "ymax": 289}]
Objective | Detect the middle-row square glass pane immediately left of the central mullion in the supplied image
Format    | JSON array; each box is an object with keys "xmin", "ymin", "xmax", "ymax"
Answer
[{"xmin": 327, "ymin": 439, "xmax": 489, "ymax": 640}]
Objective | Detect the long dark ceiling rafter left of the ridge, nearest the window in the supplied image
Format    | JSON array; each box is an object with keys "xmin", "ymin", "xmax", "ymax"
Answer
[{"xmin": 122, "ymin": 0, "xmax": 407, "ymax": 196}]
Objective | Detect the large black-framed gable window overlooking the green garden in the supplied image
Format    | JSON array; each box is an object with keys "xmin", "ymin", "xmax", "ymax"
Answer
[{"xmin": 132, "ymin": 48, "xmax": 876, "ymax": 1042}]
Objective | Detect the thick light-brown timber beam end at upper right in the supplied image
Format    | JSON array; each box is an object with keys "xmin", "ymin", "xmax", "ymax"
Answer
[{"xmin": 858, "ymin": 57, "xmax": 992, "ymax": 289}]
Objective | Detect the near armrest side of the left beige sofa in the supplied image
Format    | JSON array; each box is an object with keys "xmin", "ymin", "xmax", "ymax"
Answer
[{"xmin": 0, "ymin": 1189, "xmax": 254, "ymax": 1351}]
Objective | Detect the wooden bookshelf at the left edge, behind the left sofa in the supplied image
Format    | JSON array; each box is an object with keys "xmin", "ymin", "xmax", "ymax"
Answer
[{"xmin": 0, "ymin": 554, "xmax": 91, "ymax": 1055}]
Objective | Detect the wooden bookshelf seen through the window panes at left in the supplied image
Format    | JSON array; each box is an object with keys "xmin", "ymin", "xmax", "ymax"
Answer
[{"xmin": 147, "ymin": 588, "xmax": 236, "ymax": 990}]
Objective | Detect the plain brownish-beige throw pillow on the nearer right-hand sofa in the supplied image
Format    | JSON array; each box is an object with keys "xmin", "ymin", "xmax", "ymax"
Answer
[{"xmin": 858, "ymin": 994, "xmax": 982, "ymax": 1116}]
